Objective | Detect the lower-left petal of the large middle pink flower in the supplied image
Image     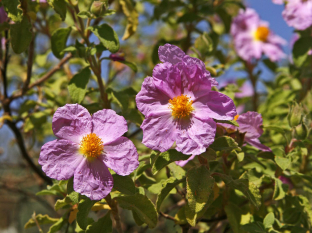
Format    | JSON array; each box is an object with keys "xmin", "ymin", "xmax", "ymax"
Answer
[{"xmin": 141, "ymin": 110, "xmax": 177, "ymax": 152}]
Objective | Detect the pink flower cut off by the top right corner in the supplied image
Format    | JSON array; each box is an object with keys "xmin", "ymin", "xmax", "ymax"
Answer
[{"xmin": 273, "ymin": 0, "xmax": 312, "ymax": 30}]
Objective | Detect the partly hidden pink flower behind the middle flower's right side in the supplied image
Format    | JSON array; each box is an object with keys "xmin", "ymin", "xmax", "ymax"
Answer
[{"xmin": 218, "ymin": 112, "xmax": 271, "ymax": 151}]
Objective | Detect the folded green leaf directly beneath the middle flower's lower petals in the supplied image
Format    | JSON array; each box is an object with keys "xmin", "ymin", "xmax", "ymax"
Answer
[{"xmin": 151, "ymin": 149, "xmax": 190, "ymax": 175}]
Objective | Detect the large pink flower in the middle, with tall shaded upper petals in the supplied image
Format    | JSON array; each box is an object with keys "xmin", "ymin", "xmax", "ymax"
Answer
[{"xmin": 136, "ymin": 44, "xmax": 236, "ymax": 155}]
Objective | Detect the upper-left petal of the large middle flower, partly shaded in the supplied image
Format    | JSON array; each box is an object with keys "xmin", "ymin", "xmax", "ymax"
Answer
[{"xmin": 135, "ymin": 77, "xmax": 170, "ymax": 116}]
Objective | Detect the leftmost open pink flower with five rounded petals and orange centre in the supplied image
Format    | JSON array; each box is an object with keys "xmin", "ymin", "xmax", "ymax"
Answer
[{"xmin": 39, "ymin": 104, "xmax": 139, "ymax": 200}]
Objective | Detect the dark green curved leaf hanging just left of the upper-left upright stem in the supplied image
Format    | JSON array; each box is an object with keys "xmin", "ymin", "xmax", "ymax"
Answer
[{"xmin": 51, "ymin": 27, "xmax": 71, "ymax": 59}]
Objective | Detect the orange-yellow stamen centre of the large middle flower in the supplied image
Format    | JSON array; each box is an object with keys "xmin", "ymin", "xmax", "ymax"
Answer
[{"xmin": 169, "ymin": 95, "xmax": 194, "ymax": 118}]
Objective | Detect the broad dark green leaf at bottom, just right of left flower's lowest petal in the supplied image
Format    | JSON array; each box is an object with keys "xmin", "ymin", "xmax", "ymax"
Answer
[{"xmin": 115, "ymin": 193, "xmax": 158, "ymax": 228}]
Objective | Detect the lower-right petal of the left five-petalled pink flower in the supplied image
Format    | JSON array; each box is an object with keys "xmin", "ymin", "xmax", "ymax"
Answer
[{"xmin": 102, "ymin": 137, "xmax": 139, "ymax": 176}]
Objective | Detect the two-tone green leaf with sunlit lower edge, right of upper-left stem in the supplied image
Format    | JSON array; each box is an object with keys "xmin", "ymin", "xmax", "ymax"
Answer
[{"xmin": 88, "ymin": 24, "xmax": 120, "ymax": 53}]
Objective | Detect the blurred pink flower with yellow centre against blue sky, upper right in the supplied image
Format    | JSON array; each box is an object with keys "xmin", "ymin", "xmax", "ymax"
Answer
[{"xmin": 231, "ymin": 8, "xmax": 286, "ymax": 61}]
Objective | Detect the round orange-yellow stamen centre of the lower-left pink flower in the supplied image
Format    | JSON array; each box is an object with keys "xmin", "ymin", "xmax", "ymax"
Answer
[{"xmin": 80, "ymin": 133, "xmax": 104, "ymax": 159}]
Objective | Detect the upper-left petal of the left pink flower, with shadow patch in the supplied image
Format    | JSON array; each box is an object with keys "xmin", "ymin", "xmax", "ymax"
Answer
[{"xmin": 52, "ymin": 104, "xmax": 92, "ymax": 144}]
